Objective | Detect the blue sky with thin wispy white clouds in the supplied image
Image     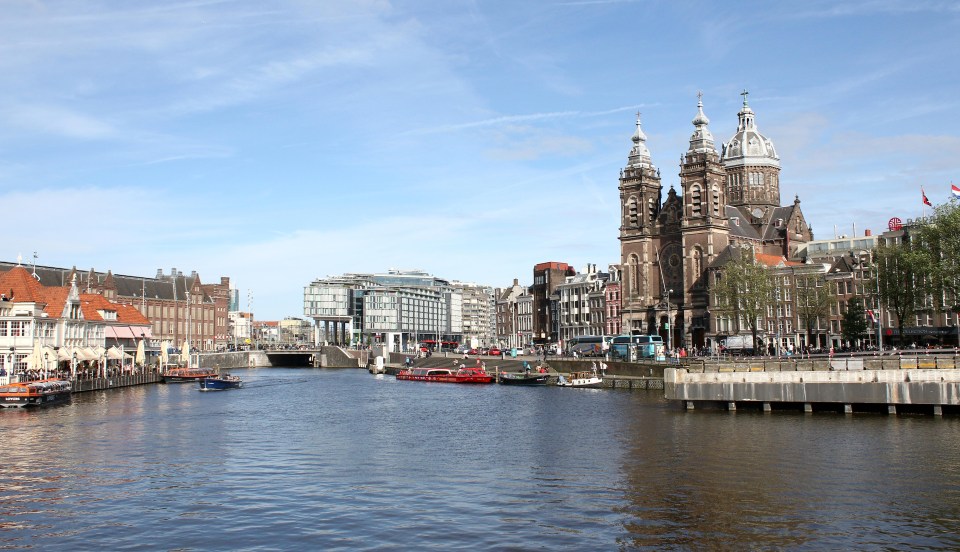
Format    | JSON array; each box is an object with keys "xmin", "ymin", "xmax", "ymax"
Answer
[{"xmin": 0, "ymin": 0, "xmax": 960, "ymax": 320}]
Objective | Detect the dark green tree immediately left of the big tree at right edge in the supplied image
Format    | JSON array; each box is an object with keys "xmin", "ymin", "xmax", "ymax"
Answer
[{"xmin": 874, "ymin": 237, "xmax": 929, "ymax": 346}]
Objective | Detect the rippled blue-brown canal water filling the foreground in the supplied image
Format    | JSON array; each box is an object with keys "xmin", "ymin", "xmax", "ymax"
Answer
[{"xmin": 0, "ymin": 369, "xmax": 960, "ymax": 550}]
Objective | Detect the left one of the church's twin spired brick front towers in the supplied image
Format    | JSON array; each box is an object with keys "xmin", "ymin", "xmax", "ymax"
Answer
[{"xmin": 620, "ymin": 113, "xmax": 663, "ymax": 333}]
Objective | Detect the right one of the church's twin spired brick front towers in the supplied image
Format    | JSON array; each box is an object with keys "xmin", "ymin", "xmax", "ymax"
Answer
[{"xmin": 680, "ymin": 94, "xmax": 730, "ymax": 347}]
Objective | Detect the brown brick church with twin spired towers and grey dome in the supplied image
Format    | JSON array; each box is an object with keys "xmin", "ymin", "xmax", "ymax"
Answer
[{"xmin": 619, "ymin": 92, "xmax": 813, "ymax": 347}]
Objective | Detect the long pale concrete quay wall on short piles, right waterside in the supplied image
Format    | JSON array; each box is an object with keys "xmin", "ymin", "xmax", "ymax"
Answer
[{"xmin": 664, "ymin": 368, "xmax": 960, "ymax": 413}]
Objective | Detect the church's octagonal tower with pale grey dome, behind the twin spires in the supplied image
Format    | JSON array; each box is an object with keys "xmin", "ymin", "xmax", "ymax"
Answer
[{"xmin": 721, "ymin": 90, "xmax": 780, "ymax": 224}]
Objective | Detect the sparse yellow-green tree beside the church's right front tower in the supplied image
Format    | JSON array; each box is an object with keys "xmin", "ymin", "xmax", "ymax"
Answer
[{"xmin": 713, "ymin": 247, "xmax": 774, "ymax": 351}]
